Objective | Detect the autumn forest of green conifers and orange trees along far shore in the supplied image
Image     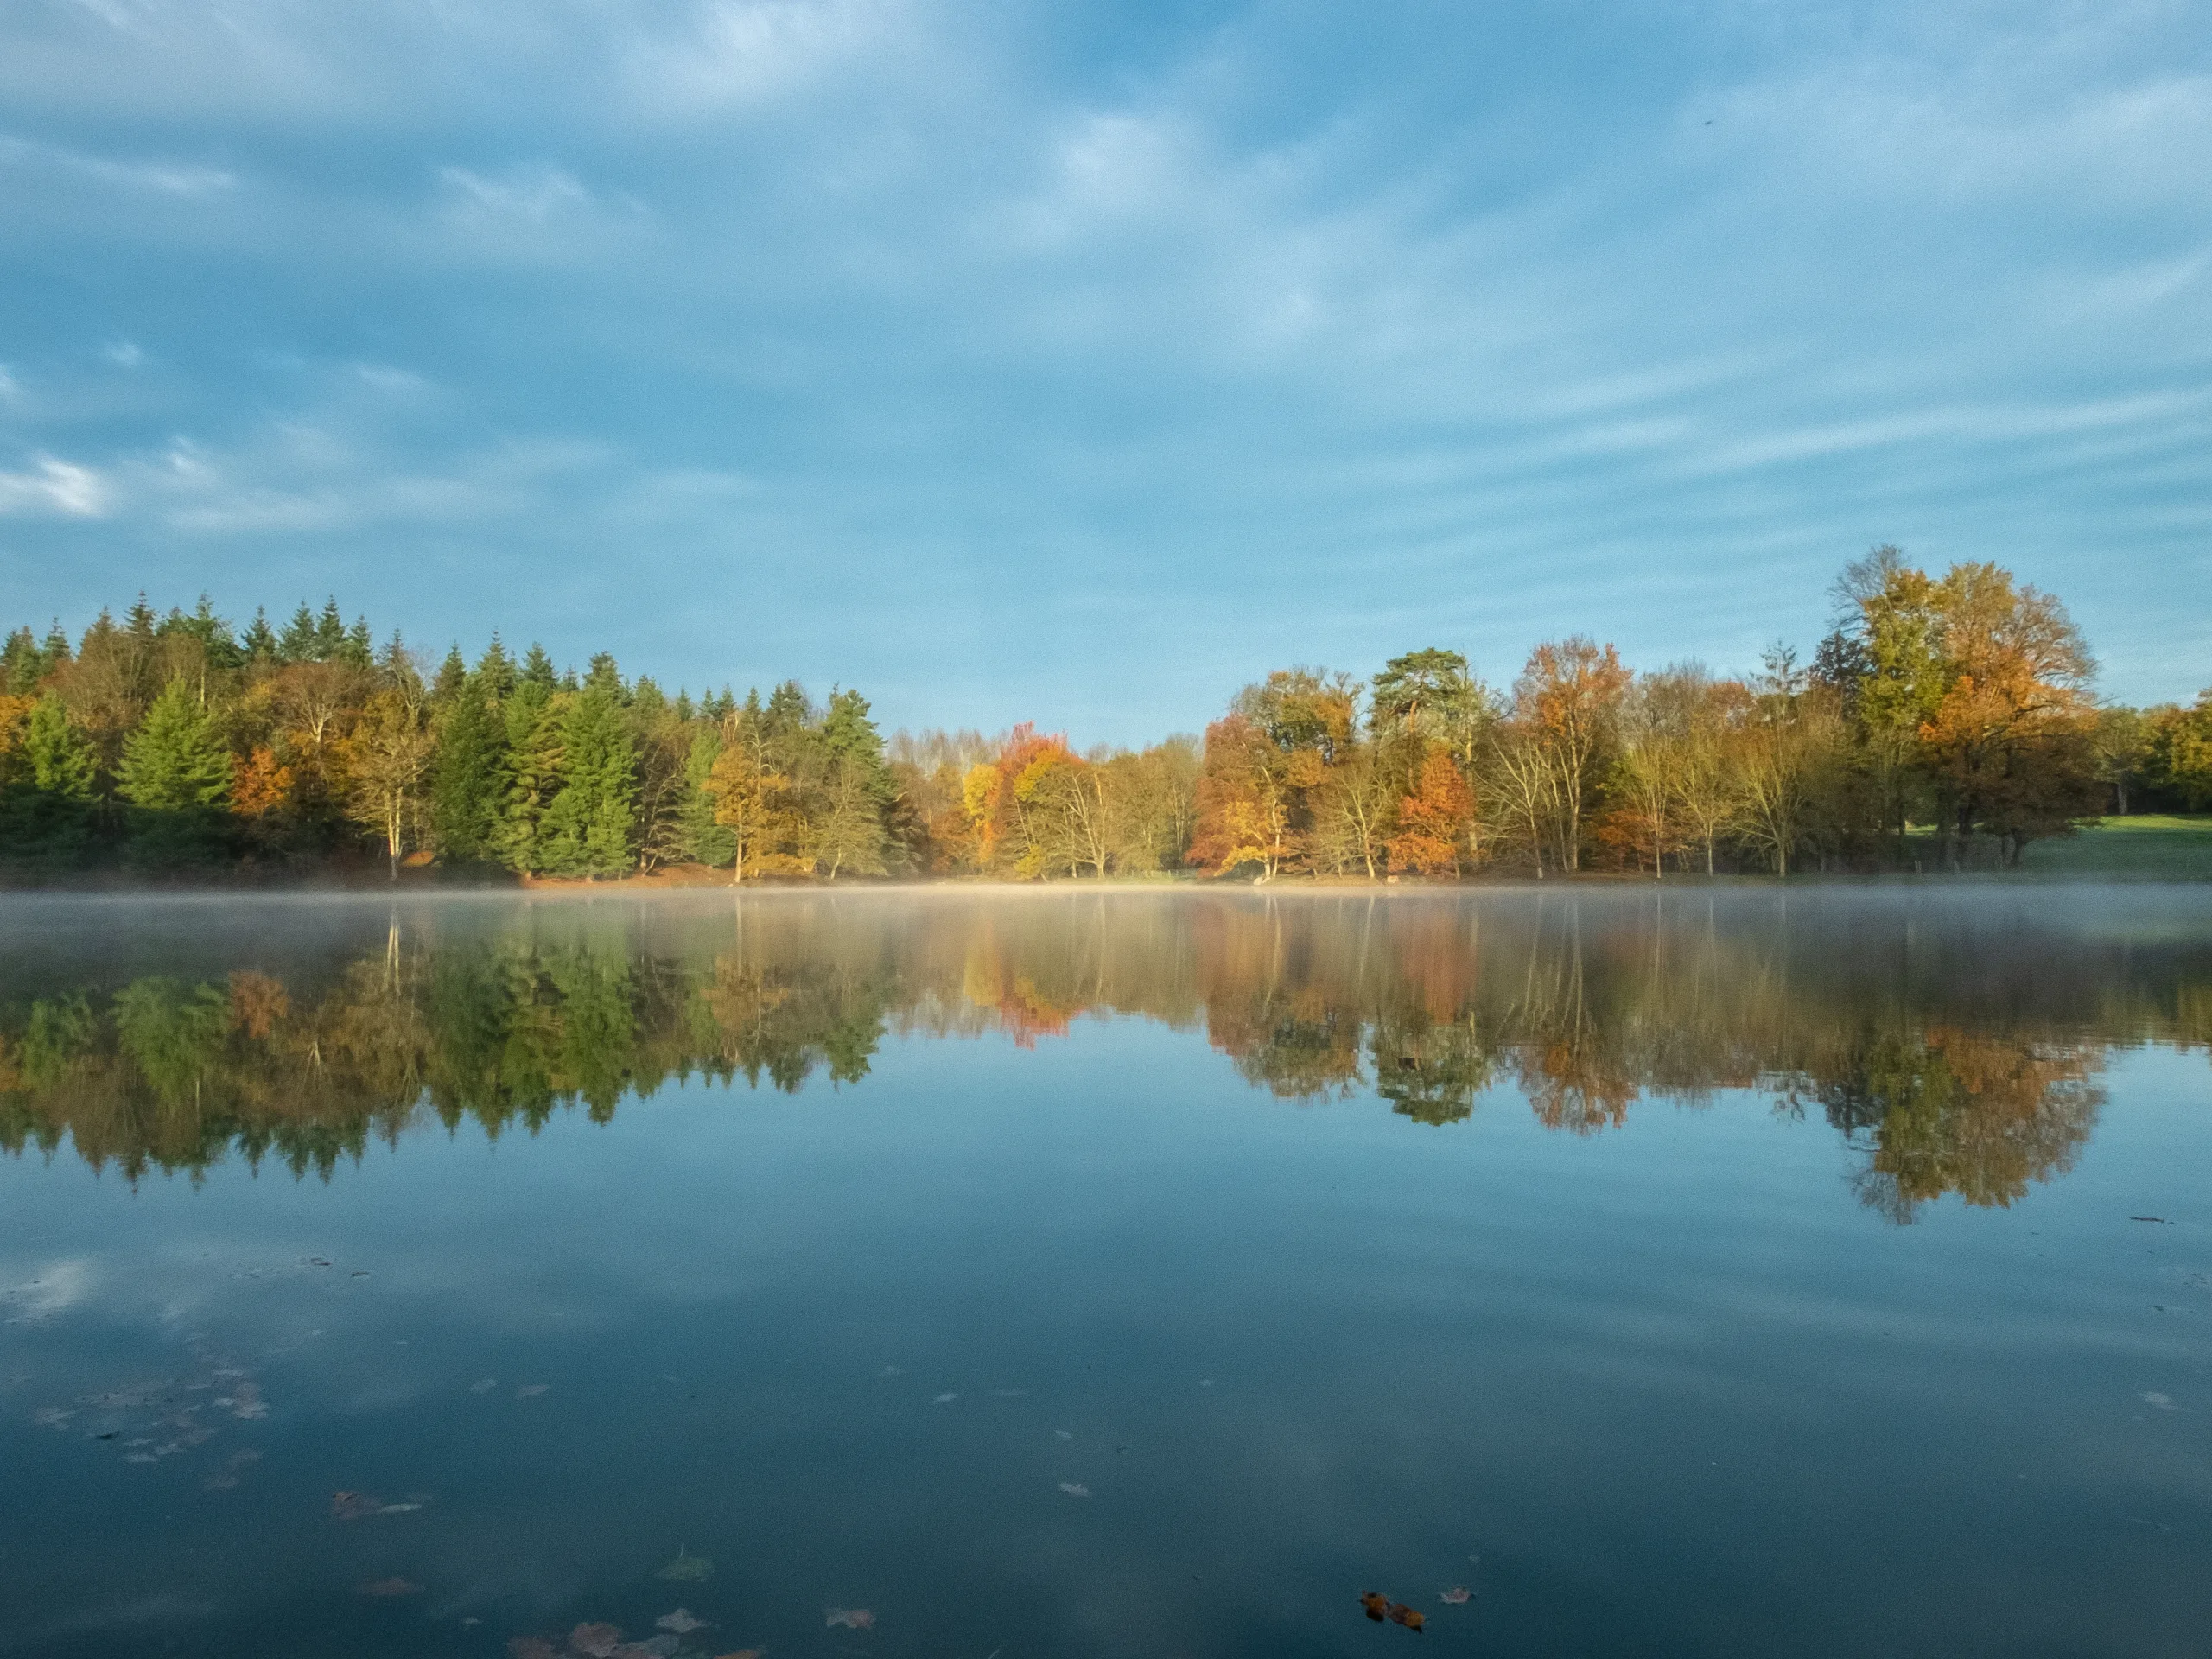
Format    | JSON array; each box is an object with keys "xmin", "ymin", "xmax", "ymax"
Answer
[{"xmin": 0, "ymin": 546, "xmax": 2212, "ymax": 885}]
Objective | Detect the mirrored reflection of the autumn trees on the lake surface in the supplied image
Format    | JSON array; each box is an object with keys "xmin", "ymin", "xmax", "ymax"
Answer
[{"xmin": 0, "ymin": 892, "xmax": 2212, "ymax": 1221}]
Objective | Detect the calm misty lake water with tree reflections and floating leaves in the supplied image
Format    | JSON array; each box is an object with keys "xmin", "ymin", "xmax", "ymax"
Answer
[{"xmin": 0, "ymin": 887, "xmax": 2212, "ymax": 1659}]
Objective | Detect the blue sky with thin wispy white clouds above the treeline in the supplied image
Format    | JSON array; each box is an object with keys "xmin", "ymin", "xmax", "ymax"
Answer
[{"xmin": 0, "ymin": 0, "xmax": 2212, "ymax": 743}]
